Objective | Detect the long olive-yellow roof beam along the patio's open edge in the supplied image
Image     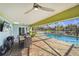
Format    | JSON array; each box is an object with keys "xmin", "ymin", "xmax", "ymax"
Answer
[{"xmin": 31, "ymin": 5, "xmax": 79, "ymax": 26}]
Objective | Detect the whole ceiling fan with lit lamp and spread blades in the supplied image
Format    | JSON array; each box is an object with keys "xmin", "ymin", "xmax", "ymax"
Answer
[{"xmin": 24, "ymin": 3, "xmax": 54, "ymax": 14}]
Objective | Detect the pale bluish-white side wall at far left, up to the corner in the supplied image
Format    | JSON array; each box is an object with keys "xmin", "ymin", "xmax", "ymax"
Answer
[{"xmin": 0, "ymin": 16, "xmax": 12, "ymax": 46}]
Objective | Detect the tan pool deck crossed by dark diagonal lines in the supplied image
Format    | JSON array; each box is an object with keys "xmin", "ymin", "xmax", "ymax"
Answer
[{"xmin": 21, "ymin": 34, "xmax": 79, "ymax": 56}]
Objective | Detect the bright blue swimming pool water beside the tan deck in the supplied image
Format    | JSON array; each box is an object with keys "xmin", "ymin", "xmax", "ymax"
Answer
[{"xmin": 46, "ymin": 34, "xmax": 79, "ymax": 46}]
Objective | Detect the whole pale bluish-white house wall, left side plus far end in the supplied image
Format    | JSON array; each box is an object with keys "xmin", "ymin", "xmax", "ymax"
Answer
[{"xmin": 0, "ymin": 16, "xmax": 27, "ymax": 45}]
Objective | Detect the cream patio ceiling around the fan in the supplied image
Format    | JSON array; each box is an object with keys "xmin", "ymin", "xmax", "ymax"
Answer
[{"xmin": 0, "ymin": 3, "xmax": 77, "ymax": 25}]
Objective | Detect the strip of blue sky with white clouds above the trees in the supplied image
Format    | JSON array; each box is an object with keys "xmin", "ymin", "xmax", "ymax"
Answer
[{"xmin": 44, "ymin": 18, "xmax": 79, "ymax": 28}]
